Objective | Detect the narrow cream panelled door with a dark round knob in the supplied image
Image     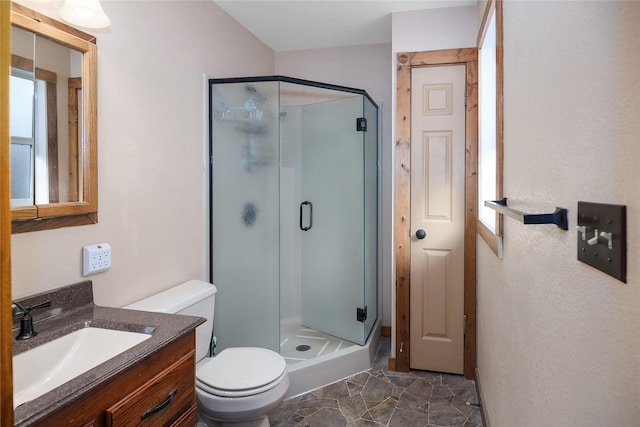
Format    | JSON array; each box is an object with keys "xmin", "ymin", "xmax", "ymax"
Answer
[{"xmin": 409, "ymin": 65, "xmax": 466, "ymax": 374}]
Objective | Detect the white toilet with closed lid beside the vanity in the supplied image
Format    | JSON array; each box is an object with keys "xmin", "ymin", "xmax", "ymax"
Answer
[{"xmin": 124, "ymin": 280, "xmax": 289, "ymax": 427}]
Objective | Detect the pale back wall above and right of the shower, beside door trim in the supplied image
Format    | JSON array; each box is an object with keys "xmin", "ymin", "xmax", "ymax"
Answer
[{"xmin": 275, "ymin": 44, "xmax": 393, "ymax": 326}]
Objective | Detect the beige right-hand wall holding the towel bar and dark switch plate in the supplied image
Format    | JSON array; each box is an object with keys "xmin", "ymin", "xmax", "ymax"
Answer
[{"xmin": 478, "ymin": 1, "xmax": 640, "ymax": 427}]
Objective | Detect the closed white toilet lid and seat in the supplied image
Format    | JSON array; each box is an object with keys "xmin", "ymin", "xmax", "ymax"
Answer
[{"xmin": 196, "ymin": 347, "xmax": 287, "ymax": 396}]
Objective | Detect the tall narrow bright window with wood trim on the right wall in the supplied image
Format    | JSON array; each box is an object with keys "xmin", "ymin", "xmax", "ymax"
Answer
[{"xmin": 478, "ymin": 0, "xmax": 503, "ymax": 257}]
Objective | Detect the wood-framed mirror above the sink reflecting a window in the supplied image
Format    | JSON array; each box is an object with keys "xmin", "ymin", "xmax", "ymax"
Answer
[{"xmin": 10, "ymin": 3, "xmax": 98, "ymax": 233}]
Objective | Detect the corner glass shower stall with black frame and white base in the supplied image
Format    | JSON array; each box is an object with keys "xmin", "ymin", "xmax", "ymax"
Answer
[{"xmin": 209, "ymin": 76, "xmax": 378, "ymax": 395}]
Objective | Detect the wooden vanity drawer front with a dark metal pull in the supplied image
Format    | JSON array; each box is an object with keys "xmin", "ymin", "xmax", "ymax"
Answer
[{"xmin": 106, "ymin": 352, "xmax": 195, "ymax": 427}]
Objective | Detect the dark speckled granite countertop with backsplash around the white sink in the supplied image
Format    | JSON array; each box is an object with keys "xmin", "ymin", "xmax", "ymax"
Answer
[{"xmin": 13, "ymin": 281, "xmax": 205, "ymax": 425}]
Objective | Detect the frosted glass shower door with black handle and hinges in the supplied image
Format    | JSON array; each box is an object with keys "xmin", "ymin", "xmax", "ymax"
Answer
[{"xmin": 300, "ymin": 95, "xmax": 364, "ymax": 344}]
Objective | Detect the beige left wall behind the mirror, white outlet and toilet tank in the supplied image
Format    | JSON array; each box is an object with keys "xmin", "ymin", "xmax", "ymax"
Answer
[{"xmin": 12, "ymin": 1, "xmax": 274, "ymax": 306}]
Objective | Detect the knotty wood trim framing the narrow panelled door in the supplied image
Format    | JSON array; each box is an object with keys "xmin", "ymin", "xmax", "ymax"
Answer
[{"xmin": 389, "ymin": 48, "xmax": 478, "ymax": 379}]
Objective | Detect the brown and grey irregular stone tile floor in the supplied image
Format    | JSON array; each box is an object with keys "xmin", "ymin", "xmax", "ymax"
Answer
[{"xmin": 269, "ymin": 337, "xmax": 482, "ymax": 427}]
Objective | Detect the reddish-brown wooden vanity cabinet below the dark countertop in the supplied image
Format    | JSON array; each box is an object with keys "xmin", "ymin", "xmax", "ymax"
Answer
[{"xmin": 47, "ymin": 331, "xmax": 197, "ymax": 427}]
